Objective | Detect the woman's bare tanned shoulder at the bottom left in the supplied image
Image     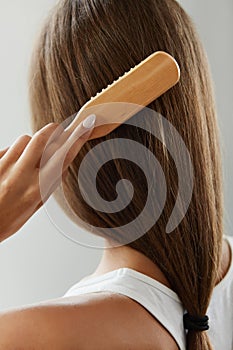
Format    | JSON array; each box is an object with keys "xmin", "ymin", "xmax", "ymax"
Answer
[{"xmin": 0, "ymin": 292, "xmax": 178, "ymax": 350}]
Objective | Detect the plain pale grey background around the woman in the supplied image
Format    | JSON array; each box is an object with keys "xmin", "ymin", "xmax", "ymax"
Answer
[{"xmin": 0, "ymin": 0, "xmax": 233, "ymax": 309}]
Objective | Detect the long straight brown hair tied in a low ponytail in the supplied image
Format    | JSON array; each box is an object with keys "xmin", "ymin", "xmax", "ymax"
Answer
[{"xmin": 30, "ymin": 0, "xmax": 223, "ymax": 350}]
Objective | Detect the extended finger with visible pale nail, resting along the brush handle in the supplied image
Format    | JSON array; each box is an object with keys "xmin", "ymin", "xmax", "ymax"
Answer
[{"xmin": 40, "ymin": 115, "xmax": 96, "ymax": 201}]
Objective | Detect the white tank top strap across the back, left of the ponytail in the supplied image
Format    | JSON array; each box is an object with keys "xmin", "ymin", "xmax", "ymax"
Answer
[{"xmin": 63, "ymin": 267, "xmax": 186, "ymax": 350}]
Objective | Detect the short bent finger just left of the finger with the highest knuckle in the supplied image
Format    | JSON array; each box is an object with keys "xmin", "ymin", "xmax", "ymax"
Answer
[{"xmin": 1, "ymin": 135, "xmax": 31, "ymax": 164}]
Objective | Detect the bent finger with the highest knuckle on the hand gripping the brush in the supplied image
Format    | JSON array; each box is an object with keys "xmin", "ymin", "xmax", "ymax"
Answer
[{"xmin": 19, "ymin": 123, "xmax": 64, "ymax": 168}]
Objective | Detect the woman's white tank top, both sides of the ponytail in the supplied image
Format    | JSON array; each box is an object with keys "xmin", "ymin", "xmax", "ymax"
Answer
[{"xmin": 63, "ymin": 236, "xmax": 233, "ymax": 350}]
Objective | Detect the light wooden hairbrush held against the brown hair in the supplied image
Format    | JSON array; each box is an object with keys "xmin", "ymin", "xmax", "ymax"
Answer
[{"xmin": 67, "ymin": 51, "xmax": 180, "ymax": 140}]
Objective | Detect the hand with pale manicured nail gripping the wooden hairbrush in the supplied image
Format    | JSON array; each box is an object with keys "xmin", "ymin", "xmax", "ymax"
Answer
[{"xmin": 0, "ymin": 115, "xmax": 95, "ymax": 242}]
